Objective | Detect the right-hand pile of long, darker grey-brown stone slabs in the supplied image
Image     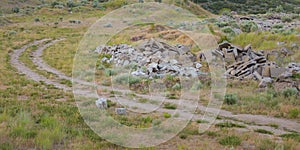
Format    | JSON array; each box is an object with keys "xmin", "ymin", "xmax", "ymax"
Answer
[{"xmin": 212, "ymin": 42, "xmax": 300, "ymax": 87}]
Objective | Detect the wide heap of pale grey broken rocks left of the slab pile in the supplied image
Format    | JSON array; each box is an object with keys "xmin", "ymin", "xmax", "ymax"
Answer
[{"xmin": 96, "ymin": 39, "xmax": 202, "ymax": 77}]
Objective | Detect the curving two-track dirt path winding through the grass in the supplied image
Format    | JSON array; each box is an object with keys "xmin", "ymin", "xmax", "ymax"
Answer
[{"xmin": 10, "ymin": 39, "xmax": 300, "ymax": 135}]
